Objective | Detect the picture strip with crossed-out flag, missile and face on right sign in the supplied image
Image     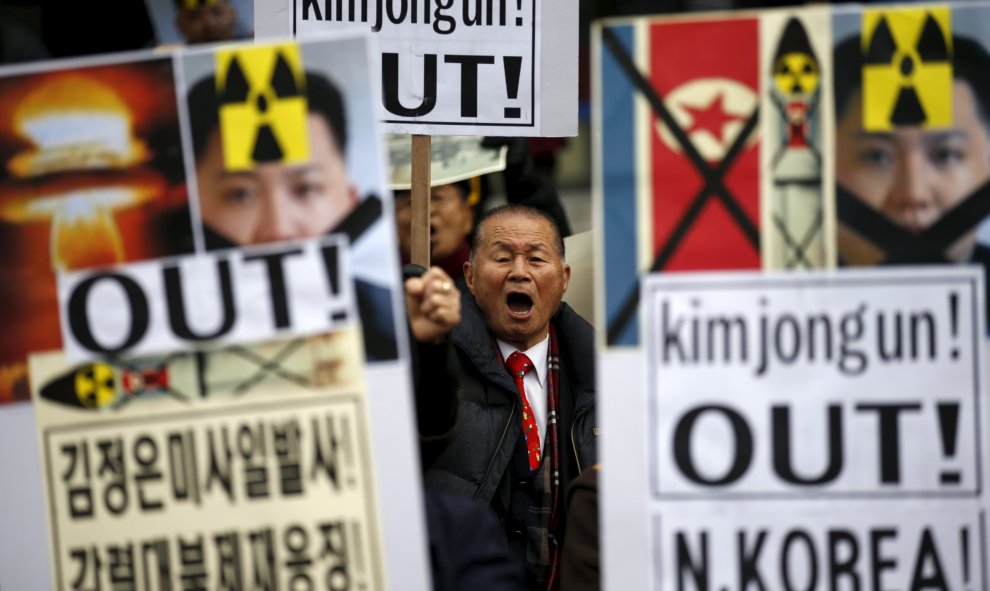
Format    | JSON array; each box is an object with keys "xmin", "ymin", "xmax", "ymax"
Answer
[{"xmin": 593, "ymin": 2, "xmax": 990, "ymax": 347}]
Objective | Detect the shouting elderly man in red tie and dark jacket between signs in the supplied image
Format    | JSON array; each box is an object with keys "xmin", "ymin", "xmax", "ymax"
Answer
[{"xmin": 426, "ymin": 205, "xmax": 597, "ymax": 589}]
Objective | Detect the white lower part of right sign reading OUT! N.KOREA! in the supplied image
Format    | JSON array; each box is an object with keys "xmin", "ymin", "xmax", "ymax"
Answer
[{"xmin": 624, "ymin": 267, "xmax": 990, "ymax": 591}]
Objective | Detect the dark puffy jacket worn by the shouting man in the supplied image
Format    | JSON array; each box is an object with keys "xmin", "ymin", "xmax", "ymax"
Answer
[{"xmin": 426, "ymin": 292, "xmax": 598, "ymax": 517}]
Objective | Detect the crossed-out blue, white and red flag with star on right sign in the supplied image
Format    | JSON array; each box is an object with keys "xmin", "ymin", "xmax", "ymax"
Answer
[{"xmin": 595, "ymin": 18, "xmax": 760, "ymax": 345}]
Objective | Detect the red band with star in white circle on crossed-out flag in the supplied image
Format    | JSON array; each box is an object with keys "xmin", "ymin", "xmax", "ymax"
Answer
[{"xmin": 649, "ymin": 19, "xmax": 760, "ymax": 270}]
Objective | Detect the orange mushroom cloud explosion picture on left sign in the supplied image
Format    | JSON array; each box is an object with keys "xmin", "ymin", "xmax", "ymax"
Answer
[{"xmin": 0, "ymin": 57, "xmax": 193, "ymax": 403}]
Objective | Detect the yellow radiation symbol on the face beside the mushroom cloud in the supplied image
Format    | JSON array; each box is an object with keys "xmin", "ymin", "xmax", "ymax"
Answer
[{"xmin": 216, "ymin": 43, "xmax": 309, "ymax": 171}]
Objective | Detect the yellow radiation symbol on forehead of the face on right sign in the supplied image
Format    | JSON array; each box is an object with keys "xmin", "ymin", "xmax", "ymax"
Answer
[{"xmin": 862, "ymin": 8, "xmax": 952, "ymax": 131}]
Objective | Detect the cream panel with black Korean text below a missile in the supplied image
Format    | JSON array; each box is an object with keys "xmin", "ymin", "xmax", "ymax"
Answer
[{"xmin": 31, "ymin": 328, "xmax": 384, "ymax": 589}]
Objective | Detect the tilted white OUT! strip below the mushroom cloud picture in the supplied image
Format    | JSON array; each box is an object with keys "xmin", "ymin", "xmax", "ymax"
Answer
[{"xmin": 58, "ymin": 235, "xmax": 354, "ymax": 361}]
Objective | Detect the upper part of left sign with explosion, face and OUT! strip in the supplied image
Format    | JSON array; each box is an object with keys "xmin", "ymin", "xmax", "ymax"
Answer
[{"xmin": 0, "ymin": 35, "xmax": 406, "ymax": 382}]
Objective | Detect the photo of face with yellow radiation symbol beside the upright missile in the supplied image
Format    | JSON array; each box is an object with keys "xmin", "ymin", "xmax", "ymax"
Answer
[{"xmin": 832, "ymin": 5, "xmax": 990, "ymax": 332}]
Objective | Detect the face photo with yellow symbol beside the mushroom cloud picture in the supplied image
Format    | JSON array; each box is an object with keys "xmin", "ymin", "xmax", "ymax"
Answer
[{"xmin": 183, "ymin": 36, "xmax": 398, "ymax": 361}]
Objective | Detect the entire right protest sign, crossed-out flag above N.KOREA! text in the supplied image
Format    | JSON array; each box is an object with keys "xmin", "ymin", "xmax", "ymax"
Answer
[{"xmin": 592, "ymin": 2, "xmax": 990, "ymax": 590}]
